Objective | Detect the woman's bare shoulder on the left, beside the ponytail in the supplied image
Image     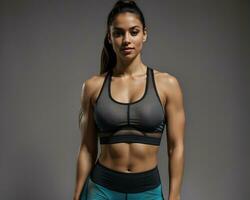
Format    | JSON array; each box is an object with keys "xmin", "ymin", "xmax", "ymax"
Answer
[{"xmin": 81, "ymin": 72, "xmax": 107, "ymax": 106}]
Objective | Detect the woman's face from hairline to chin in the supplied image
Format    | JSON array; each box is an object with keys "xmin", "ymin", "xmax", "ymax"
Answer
[{"xmin": 108, "ymin": 12, "xmax": 147, "ymax": 59}]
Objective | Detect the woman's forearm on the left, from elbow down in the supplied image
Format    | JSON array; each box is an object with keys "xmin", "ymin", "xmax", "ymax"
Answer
[{"xmin": 73, "ymin": 148, "xmax": 96, "ymax": 200}]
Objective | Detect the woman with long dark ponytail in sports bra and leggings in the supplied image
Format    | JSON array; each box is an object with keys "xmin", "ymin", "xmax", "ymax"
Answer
[{"xmin": 74, "ymin": 1, "xmax": 185, "ymax": 200}]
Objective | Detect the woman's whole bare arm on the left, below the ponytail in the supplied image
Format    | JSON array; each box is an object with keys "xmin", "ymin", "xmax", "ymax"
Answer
[{"xmin": 73, "ymin": 79, "xmax": 98, "ymax": 200}]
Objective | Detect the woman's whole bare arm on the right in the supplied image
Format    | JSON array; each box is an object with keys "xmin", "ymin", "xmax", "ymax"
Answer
[{"xmin": 165, "ymin": 76, "xmax": 185, "ymax": 200}]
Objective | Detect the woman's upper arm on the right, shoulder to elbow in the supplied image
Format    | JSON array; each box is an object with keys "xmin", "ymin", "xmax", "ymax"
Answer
[{"xmin": 165, "ymin": 77, "xmax": 185, "ymax": 148}]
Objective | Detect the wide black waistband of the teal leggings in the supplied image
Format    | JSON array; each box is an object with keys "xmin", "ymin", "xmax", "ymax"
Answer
[{"xmin": 90, "ymin": 160, "xmax": 161, "ymax": 193}]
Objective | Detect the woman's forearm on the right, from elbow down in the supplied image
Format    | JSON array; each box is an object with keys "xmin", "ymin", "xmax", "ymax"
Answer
[{"xmin": 168, "ymin": 145, "xmax": 184, "ymax": 200}]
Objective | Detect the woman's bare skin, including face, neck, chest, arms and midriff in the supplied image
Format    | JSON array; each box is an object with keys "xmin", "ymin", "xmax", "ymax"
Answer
[{"xmin": 74, "ymin": 12, "xmax": 185, "ymax": 200}]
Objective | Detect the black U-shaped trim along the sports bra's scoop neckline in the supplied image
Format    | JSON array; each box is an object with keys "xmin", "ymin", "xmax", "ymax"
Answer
[{"xmin": 108, "ymin": 66, "xmax": 149, "ymax": 105}]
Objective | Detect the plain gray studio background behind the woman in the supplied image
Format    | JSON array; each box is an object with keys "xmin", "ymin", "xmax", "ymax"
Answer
[{"xmin": 0, "ymin": 0, "xmax": 250, "ymax": 200}]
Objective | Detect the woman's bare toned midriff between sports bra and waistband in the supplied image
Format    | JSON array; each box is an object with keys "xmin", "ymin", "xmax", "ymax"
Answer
[{"xmin": 99, "ymin": 143, "xmax": 159, "ymax": 173}]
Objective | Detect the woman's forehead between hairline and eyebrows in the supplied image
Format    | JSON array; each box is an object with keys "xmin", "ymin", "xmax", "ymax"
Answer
[{"xmin": 111, "ymin": 12, "xmax": 142, "ymax": 29}]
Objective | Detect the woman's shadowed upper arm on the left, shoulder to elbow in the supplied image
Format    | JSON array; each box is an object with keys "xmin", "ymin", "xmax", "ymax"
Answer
[{"xmin": 79, "ymin": 80, "xmax": 98, "ymax": 152}]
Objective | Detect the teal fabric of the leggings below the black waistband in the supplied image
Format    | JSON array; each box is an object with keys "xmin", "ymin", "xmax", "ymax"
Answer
[{"xmin": 80, "ymin": 177, "xmax": 164, "ymax": 200}]
